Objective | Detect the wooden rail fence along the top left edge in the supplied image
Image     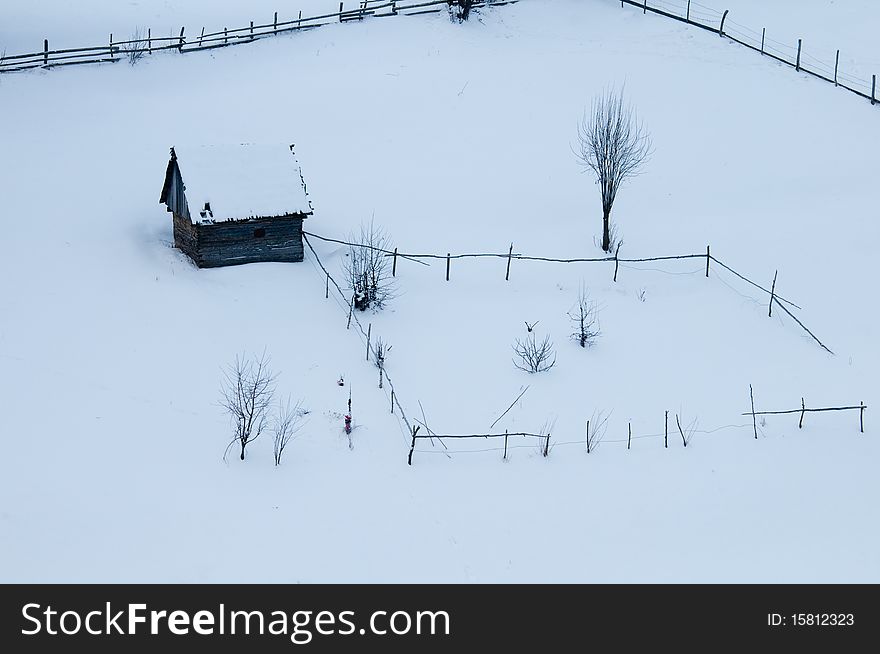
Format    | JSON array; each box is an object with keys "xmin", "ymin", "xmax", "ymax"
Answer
[{"xmin": 0, "ymin": 0, "xmax": 520, "ymax": 73}]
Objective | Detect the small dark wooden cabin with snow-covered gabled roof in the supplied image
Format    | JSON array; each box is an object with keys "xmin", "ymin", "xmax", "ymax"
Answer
[{"xmin": 159, "ymin": 143, "xmax": 312, "ymax": 268}]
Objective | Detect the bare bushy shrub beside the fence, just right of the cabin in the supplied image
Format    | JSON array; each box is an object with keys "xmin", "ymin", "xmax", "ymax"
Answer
[{"xmin": 343, "ymin": 220, "xmax": 394, "ymax": 311}]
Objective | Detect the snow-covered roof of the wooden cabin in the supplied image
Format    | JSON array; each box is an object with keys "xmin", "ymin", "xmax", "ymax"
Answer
[{"xmin": 174, "ymin": 143, "xmax": 312, "ymax": 223}]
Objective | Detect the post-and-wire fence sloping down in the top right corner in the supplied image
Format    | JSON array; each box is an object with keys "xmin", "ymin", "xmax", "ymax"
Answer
[{"xmin": 620, "ymin": 0, "xmax": 878, "ymax": 105}]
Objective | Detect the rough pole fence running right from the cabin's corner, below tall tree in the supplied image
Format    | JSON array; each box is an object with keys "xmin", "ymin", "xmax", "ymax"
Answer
[{"xmin": 303, "ymin": 230, "xmax": 834, "ymax": 355}]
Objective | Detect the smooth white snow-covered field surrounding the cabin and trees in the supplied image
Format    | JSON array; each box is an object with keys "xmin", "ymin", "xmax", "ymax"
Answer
[{"xmin": 0, "ymin": 0, "xmax": 880, "ymax": 582}]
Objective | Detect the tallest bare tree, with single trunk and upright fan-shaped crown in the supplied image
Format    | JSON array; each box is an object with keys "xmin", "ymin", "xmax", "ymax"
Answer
[{"xmin": 575, "ymin": 90, "xmax": 651, "ymax": 252}]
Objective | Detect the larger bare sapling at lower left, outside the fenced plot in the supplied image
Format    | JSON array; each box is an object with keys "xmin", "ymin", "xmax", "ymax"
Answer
[{"xmin": 220, "ymin": 352, "xmax": 275, "ymax": 461}]
